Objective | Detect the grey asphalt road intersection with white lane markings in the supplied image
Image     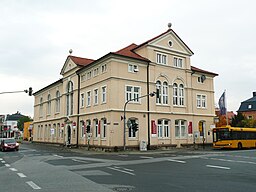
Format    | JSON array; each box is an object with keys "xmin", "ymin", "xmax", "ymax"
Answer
[{"xmin": 0, "ymin": 143, "xmax": 256, "ymax": 192}]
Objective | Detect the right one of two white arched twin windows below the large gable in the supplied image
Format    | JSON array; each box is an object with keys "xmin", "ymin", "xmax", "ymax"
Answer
[{"xmin": 173, "ymin": 83, "xmax": 185, "ymax": 106}]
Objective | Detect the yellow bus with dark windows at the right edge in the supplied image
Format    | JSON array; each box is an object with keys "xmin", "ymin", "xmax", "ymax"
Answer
[{"xmin": 213, "ymin": 126, "xmax": 256, "ymax": 149}]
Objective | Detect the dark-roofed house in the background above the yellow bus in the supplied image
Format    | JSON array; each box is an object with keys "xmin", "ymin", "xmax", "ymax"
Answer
[{"xmin": 237, "ymin": 92, "xmax": 256, "ymax": 120}]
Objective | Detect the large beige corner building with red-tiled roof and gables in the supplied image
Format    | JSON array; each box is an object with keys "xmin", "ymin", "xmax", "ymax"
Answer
[{"xmin": 33, "ymin": 26, "xmax": 217, "ymax": 149}]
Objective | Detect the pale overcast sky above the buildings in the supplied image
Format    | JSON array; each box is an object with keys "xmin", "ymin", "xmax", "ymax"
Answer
[{"xmin": 0, "ymin": 0, "xmax": 256, "ymax": 117}]
